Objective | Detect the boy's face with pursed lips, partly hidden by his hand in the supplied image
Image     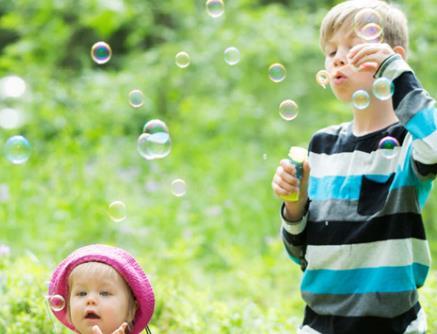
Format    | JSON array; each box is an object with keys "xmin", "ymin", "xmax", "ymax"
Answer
[{"xmin": 325, "ymin": 28, "xmax": 374, "ymax": 102}]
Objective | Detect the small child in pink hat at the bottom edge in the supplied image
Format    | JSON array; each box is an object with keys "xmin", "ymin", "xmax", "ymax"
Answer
[{"xmin": 48, "ymin": 245, "xmax": 155, "ymax": 334}]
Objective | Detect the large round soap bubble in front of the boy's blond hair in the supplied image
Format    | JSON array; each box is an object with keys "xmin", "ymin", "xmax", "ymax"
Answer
[{"xmin": 354, "ymin": 8, "xmax": 384, "ymax": 41}]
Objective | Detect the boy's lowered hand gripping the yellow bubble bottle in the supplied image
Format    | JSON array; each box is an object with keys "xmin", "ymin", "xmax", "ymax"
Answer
[{"xmin": 272, "ymin": 159, "xmax": 310, "ymax": 221}]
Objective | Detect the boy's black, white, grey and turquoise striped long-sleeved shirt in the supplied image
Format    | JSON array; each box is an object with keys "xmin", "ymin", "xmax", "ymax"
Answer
[{"xmin": 281, "ymin": 55, "xmax": 437, "ymax": 334}]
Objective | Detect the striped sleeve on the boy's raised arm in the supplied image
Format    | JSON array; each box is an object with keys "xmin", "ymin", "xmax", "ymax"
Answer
[{"xmin": 375, "ymin": 54, "xmax": 437, "ymax": 180}]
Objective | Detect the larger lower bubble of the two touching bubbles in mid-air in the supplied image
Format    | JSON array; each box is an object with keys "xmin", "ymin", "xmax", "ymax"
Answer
[{"xmin": 137, "ymin": 132, "xmax": 171, "ymax": 160}]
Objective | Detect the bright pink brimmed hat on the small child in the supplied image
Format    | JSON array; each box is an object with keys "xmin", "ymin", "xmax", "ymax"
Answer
[{"xmin": 48, "ymin": 244, "xmax": 155, "ymax": 334}]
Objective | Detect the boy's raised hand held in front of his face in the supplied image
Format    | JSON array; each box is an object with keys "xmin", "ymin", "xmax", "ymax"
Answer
[{"xmin": 347, "ymin": 43, "xmax": 395, "ymax": 72}]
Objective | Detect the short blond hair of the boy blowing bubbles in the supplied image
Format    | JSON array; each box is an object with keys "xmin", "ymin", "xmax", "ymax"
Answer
[{"xmin": 320, "ymin": 0, "xmax": 408, "ymax": 52}]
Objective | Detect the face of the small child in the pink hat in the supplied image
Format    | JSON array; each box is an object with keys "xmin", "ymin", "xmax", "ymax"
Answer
[{"xmin": 68, "ymin": 262, "xmax": 134, "ymax": 334}]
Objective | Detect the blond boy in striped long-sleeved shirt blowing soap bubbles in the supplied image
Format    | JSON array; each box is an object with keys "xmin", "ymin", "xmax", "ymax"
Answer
[{"xmin": 272, "ymin": 0, "xmax": 437, "ymax": 334}]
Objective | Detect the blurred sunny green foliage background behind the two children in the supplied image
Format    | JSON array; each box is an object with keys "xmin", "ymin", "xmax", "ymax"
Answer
[{"xmin": 0, "ymin": 0, "xmax": 437, "ymax": 334}]
